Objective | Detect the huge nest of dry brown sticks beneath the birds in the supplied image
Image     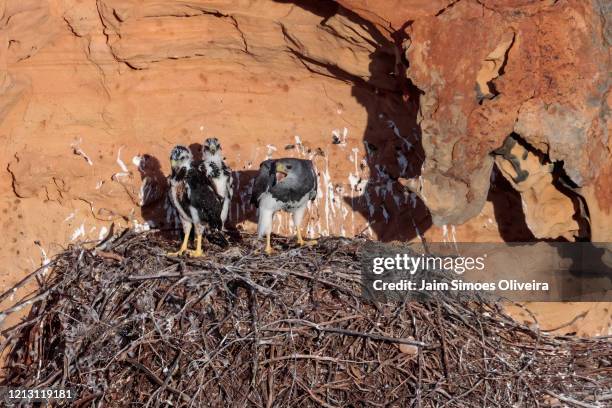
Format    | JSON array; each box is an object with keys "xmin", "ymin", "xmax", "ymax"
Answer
[{"xmin": 0, "ymin": 233, "xmax": 612, "ymax": 407}]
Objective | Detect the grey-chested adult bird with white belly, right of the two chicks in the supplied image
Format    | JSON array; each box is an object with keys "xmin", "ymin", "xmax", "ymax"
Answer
[{"xmin": 251, "ymin": 158, "xmax": 317, "ymax": 254}]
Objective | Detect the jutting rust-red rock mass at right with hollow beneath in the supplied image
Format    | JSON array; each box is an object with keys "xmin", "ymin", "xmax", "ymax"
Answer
[{"xmin": 406, "ymin": 1, "xmax": 612, "ymax": 241}]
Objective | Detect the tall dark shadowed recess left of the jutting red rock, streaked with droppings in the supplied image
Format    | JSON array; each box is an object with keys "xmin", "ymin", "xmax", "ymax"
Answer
[{"xmin": 334, "ymin": 8, "xmax": 433, "ymax": 242}]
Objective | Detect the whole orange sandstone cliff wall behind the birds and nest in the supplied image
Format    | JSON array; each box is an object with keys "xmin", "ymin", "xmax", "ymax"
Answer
[{"xmin": 0, "ymin": 0, "xmax": 612, "ymax": 332}]
